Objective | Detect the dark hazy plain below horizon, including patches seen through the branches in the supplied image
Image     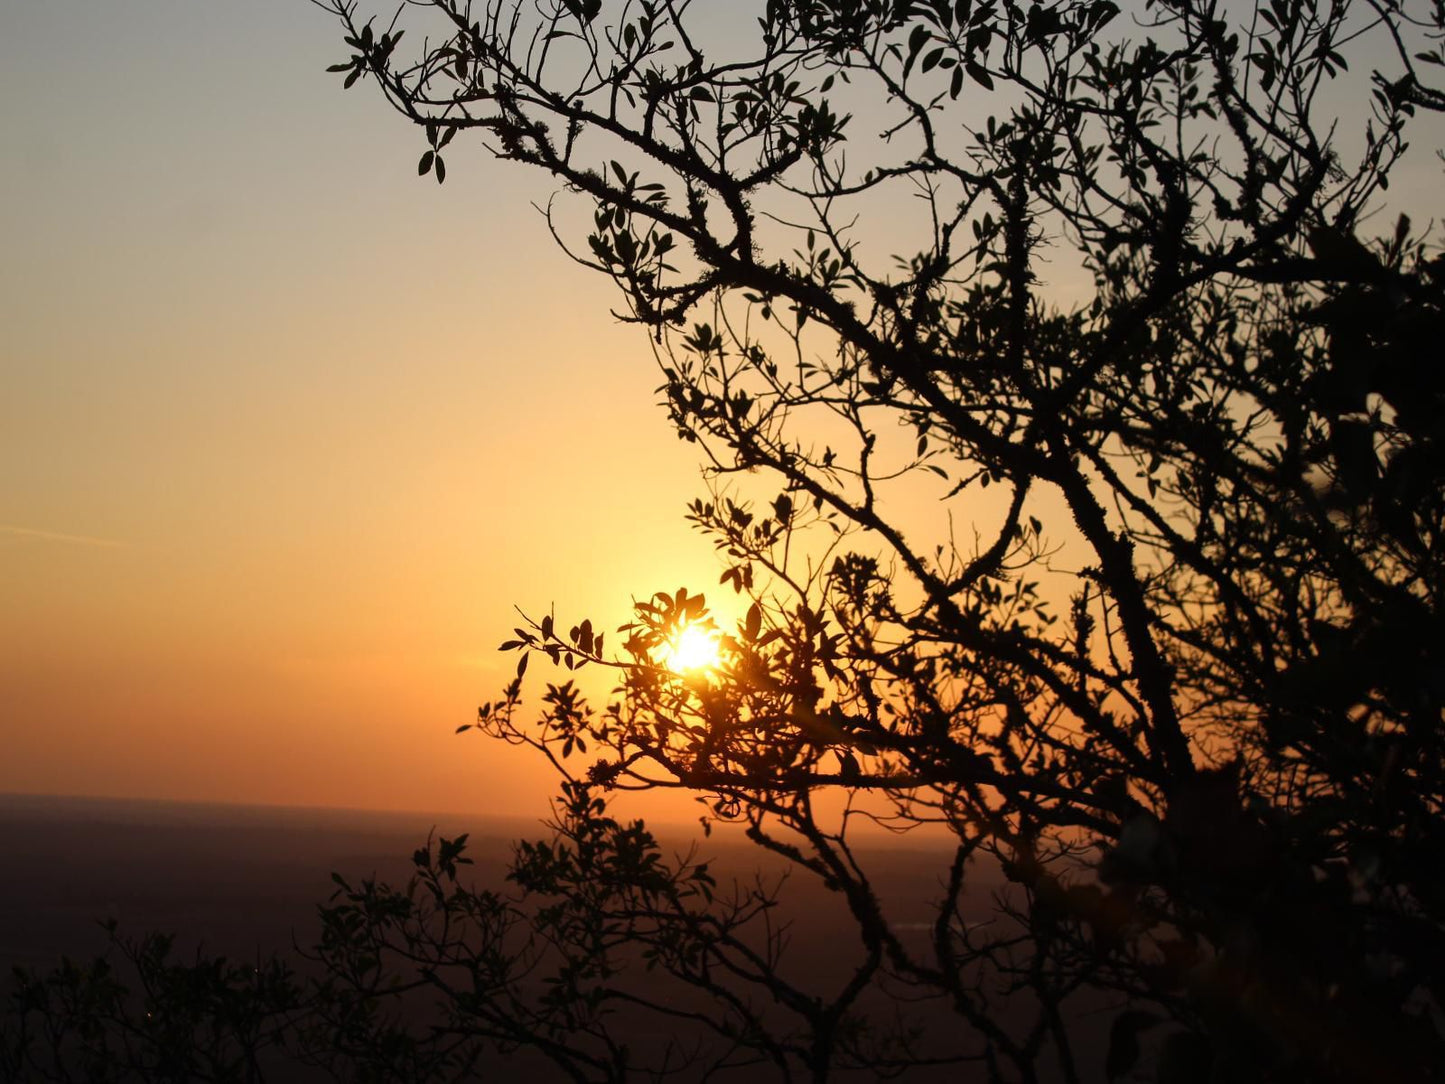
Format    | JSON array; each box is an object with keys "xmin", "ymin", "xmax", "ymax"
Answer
[{"xmin": 0, "ymin": 795, "xmax": 1103, "ymax": 1080}]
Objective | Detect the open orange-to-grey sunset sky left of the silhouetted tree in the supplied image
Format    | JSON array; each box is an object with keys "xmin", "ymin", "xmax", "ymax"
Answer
[{"xmin": 0, "ymin": 0, "xmax": 718, "ymax": 812}]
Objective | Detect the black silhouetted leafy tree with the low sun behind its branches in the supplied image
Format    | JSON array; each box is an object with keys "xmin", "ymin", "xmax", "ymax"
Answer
[{"xmin": 14, "ymin": 0, "xmax": 1445, "ymax": 1084}]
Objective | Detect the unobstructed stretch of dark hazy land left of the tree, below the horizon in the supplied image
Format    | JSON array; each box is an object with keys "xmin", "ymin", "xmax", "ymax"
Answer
[{"xmin": 0, "ymin": 795, "xmax": 536, "ymax": 974}]
